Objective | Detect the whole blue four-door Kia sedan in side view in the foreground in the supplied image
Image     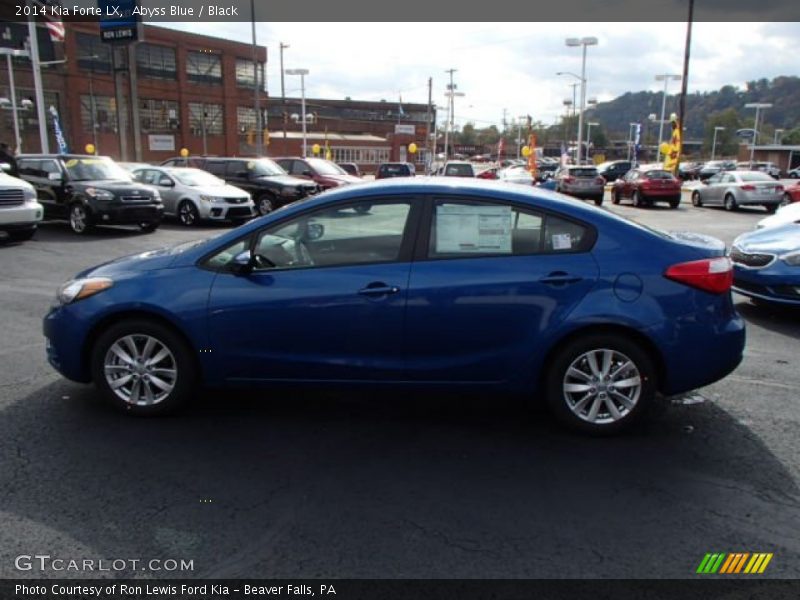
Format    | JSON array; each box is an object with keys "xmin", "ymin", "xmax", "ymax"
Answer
[{"xmin": 44, "ymin": 178, "xmax": 745, "ymax": 433}]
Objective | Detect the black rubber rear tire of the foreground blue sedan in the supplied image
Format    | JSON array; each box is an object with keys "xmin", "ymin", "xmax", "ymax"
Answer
[{"xmin": 545, "ymin": 333, "xmax": 658, "ymax": 435}]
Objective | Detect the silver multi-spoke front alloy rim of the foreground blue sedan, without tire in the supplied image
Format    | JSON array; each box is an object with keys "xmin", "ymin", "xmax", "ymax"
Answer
[{"xmin": 103, "ymin": 334, "xmax": 178, "ymax": 406}]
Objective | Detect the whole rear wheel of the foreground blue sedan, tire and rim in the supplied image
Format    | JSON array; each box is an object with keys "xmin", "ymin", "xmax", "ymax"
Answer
[{"xmin": 546, "ymin": 334, "xmax": 656, "ymax": 434}]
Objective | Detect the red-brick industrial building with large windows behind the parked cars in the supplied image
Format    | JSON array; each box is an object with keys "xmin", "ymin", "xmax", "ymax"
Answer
[{"xmin": 0, "ymin": 23, "xmax": 435, "ymax": 172}]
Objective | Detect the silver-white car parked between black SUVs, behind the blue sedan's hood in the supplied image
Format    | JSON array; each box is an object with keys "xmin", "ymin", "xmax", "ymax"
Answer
[{"xmin": 133, "ymin": 166, "xmax": 256, "ymax": 227}]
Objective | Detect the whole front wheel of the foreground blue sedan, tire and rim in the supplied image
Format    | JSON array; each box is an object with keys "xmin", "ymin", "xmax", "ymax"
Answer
[{"xmin": 91, "ymin": 319, "xmax": 198, "ymax": 416}]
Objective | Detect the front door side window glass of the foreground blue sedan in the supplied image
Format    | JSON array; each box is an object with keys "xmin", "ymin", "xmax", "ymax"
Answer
[{"xmin": 254, "ymin": 200, "xmax": 411, "ymax": 270}]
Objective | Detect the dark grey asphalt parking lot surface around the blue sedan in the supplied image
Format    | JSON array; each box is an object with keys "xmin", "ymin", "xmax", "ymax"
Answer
[{"xmin": 0, "ymin": 191, "xmax": 800, "ymax": 578}]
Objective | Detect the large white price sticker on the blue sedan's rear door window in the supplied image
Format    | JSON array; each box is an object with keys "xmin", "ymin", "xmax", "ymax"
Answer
[{"xmin": 436, "ymin": 204, "xmax": 511, "ymax": 254}]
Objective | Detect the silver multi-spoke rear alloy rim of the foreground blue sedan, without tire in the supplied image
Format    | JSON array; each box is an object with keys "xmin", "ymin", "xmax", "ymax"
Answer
[{"xmin": 562, "ymin": 348, "xmax": 642, "ymax": 425}]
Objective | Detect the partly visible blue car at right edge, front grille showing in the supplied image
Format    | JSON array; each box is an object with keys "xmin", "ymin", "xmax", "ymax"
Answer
[{"xmin": 731, "ymin": 223, "xmax": 800, "ymax": 306}]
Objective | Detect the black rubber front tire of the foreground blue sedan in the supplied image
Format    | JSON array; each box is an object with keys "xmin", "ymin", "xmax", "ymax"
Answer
[{"xmin": 90, "ymin": 319, "xmax": 199, "ymax": 417}]
